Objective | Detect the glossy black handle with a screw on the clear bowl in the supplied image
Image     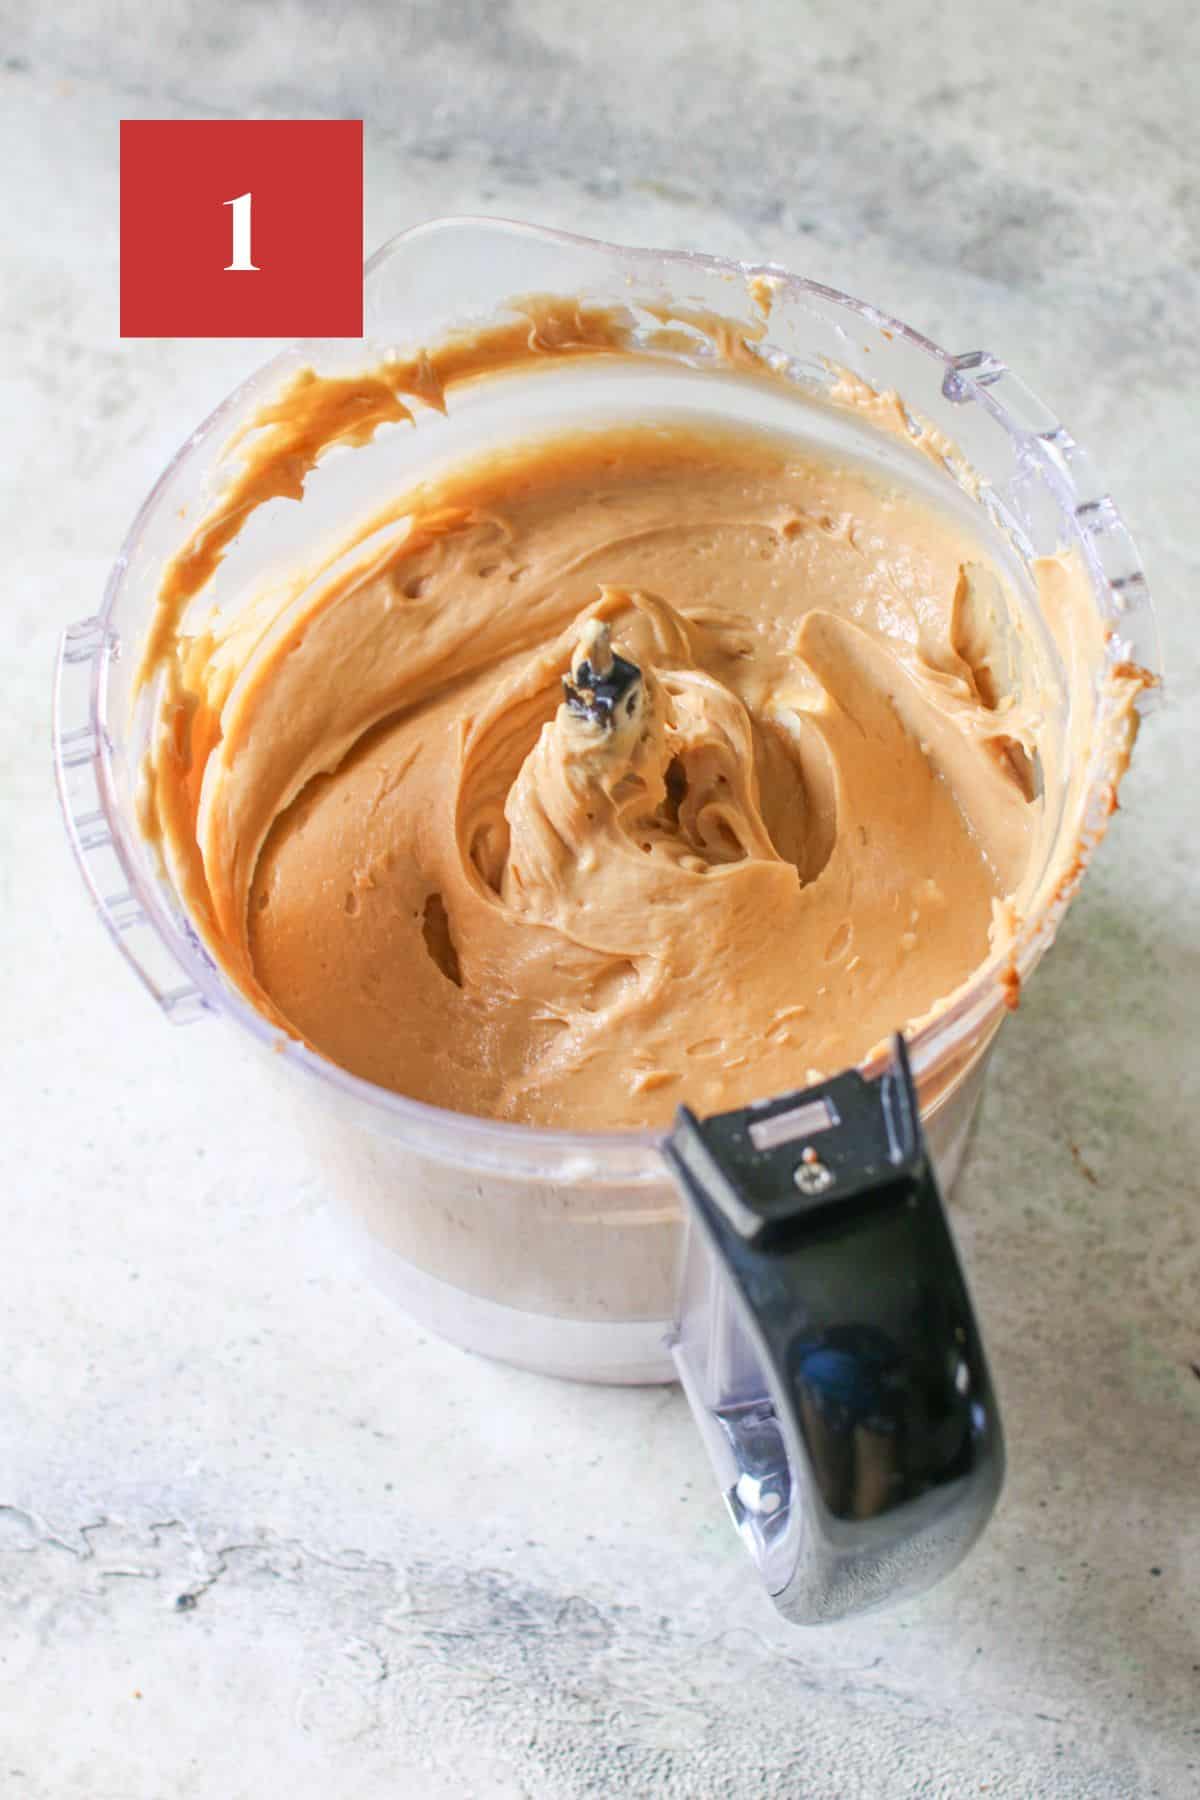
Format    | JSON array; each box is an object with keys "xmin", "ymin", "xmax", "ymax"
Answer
[{"xmin": 664, "ymin": 1037, "xmax": 1004, "ymax": 1624}]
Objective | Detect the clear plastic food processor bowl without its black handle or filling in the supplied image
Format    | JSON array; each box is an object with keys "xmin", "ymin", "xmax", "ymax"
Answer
[{"xmin": 54, "ymin": 220, "xmax": 1157, "ymax": 1382}]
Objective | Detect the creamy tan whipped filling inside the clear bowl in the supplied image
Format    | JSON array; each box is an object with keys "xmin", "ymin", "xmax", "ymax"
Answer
[{"xmin": 141, "ymin": 425, "xmax": 1061, "ymax": 1127}]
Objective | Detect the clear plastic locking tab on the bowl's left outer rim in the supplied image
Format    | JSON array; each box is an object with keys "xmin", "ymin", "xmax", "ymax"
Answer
[{"xmin": 52, "ymin": 619, "xmax": 207, "ymax": 1024}]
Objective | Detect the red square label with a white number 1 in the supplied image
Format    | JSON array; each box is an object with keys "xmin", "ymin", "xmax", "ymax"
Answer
[{"xmin": 121, "ymin": 119, "xmax": 362, "ymax": 337}]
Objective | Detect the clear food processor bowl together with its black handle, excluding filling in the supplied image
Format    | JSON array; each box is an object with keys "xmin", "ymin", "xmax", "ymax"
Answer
[{"xmin": 54, "ymin": 220, "xmax": 1159, "ymax": 1624}]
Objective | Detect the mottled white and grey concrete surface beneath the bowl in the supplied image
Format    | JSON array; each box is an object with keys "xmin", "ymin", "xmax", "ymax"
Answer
[{"xmin": 0, "ymin": 0, "xmax": 1200, "ymax": 1800}]
